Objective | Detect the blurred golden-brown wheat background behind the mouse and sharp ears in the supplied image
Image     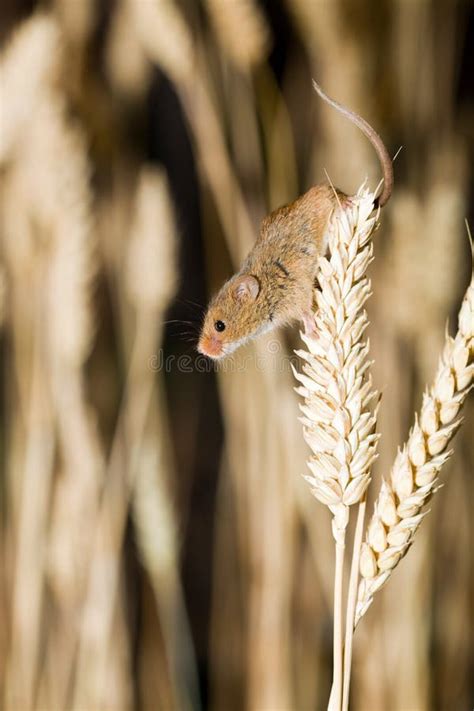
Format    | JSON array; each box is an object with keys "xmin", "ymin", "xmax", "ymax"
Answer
[{"xmin": 0, "ymin": 0, "xmax": 474, "ymax": 711}]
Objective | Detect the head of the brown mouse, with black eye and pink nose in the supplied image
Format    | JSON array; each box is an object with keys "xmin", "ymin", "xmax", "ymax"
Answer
[{"xmin": 198, "ymin": 274, "xmax": 262, "ymax": 359}]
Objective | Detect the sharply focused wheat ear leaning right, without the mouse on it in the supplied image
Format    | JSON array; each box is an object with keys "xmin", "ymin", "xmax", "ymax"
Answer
[{"xmin": 355, "ymin": 279, "xmax": 474, "ymax": 624}]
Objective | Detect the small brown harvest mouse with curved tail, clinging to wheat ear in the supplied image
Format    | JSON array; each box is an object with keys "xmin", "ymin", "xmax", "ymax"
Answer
[{"xmin": 198, "ymin": 82, "xmax": 393, "ymax": 360}]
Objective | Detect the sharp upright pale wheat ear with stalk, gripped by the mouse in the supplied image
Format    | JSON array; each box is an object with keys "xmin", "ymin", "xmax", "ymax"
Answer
[{"xmin": 294, "ymin": 186, "xmax": 378, "ymax": 709}]
